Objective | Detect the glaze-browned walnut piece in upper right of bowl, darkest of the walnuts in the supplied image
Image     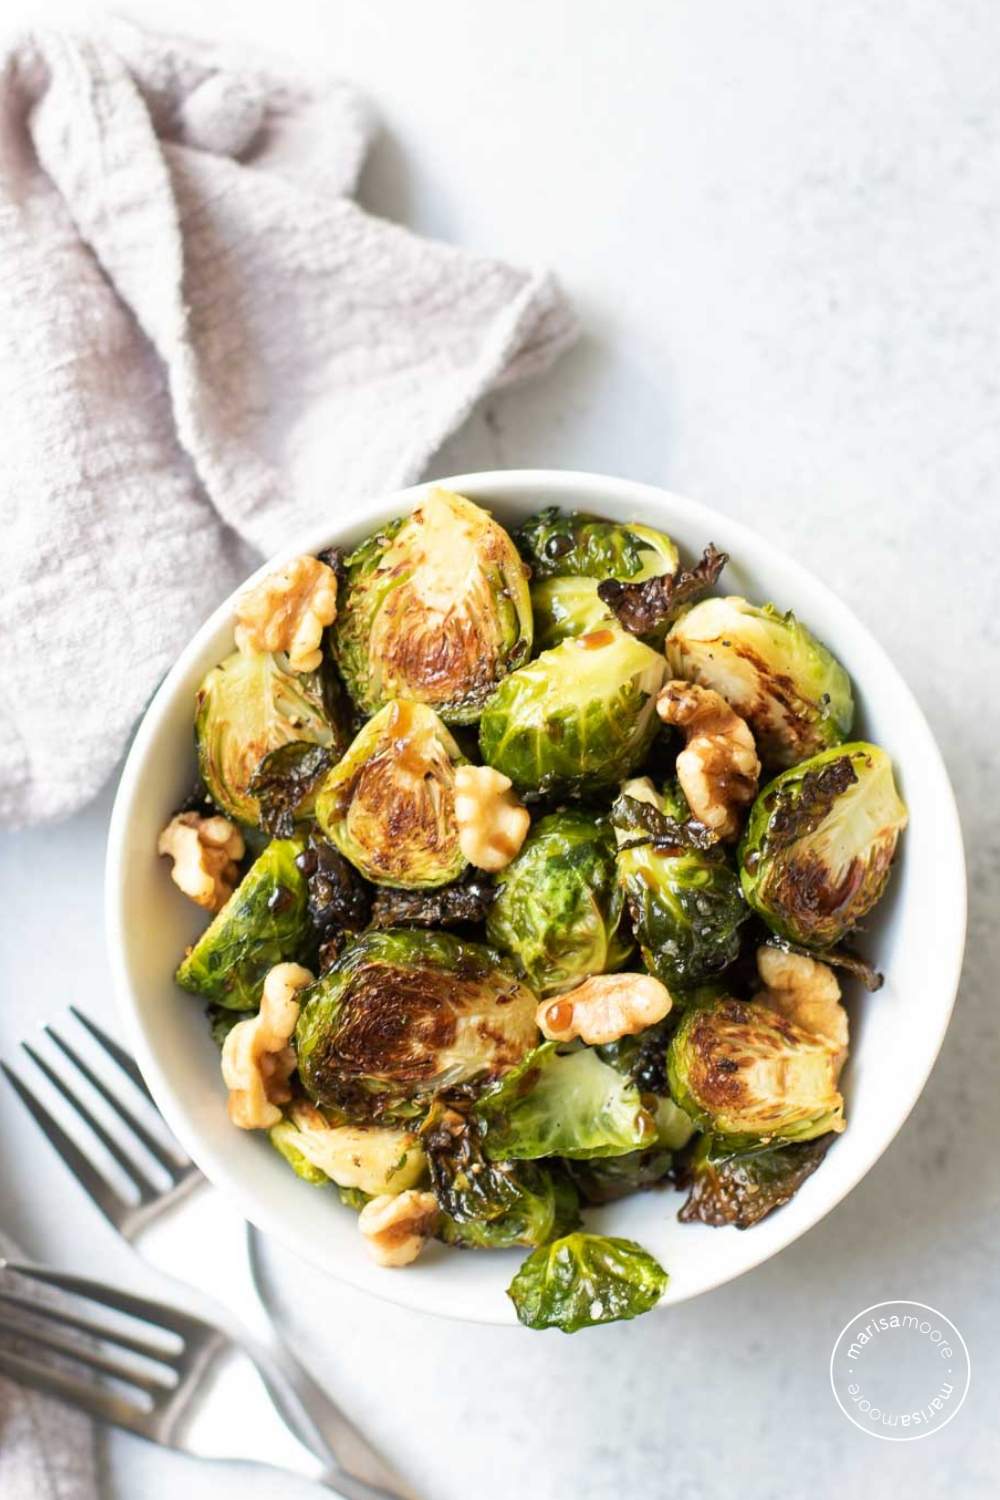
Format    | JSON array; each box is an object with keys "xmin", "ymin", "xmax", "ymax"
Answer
[{"xmin": 657, "ymin": 681, "xmax": 760, "ymax": 839}]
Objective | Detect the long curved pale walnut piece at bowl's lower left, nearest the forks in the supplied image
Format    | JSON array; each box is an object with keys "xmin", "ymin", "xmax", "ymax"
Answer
[{"xmin": 222, "ymin": 963, "xmax": 313, "ymax": 1130}]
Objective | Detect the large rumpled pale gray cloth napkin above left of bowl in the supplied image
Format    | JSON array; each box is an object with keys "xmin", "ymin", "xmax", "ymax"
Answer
[{"xmin": 0, "ymin": 23, "xmax": 574, "ymax": 824}]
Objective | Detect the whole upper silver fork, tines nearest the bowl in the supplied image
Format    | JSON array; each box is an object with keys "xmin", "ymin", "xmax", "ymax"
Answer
[{"xmin": 0, "ymin": 1005, "xmax": 417, "ymax": 1500}]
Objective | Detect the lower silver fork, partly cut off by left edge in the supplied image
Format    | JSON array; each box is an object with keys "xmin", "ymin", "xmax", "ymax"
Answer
[{"xmin": 0, "ymin": 1259, "xmax": 350, "ymax": 1494}]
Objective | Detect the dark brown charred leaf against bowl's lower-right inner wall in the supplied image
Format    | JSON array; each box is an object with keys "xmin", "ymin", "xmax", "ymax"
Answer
[{"xmin": 678, "ymin": 1133, "xmax": 834, "ymax": 1229}]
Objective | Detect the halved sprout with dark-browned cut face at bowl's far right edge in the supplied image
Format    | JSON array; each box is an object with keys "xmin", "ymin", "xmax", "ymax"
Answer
[{"xmin": 739, "ymin": 741, "xmax": 907, "ymax": 948}]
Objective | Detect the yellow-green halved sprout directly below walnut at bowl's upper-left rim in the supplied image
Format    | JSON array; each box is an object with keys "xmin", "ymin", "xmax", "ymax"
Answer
[{"xmin": 195, "ymin": 651, "xmax": 348, "ymax": 824}]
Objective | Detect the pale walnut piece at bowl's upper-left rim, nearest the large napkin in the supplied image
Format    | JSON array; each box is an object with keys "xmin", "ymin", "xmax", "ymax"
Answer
[{"xmin": 234, "ymin": 557, "xmax": 337, "ymax": 672}]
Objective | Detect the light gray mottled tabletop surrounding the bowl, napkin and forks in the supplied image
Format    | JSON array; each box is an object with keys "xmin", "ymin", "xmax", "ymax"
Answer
[{"xmin": 0, "ymin": 0, "xmax": 1000, "ymax": 1500}]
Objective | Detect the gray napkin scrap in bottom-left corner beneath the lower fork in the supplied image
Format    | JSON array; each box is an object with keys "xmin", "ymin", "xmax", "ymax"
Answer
[{"xmin": 0, "ymin": 1235, "xmax": 97, "ymax": 1500}]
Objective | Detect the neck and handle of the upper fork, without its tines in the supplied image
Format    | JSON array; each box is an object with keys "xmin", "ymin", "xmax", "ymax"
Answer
[{"xmin": 138, "ymin": 1184, "xmax": 417, "ymax": 1500}]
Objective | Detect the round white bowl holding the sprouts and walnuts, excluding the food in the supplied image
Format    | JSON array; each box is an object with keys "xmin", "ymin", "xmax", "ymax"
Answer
[{"xmin": 106, "ymin": 470, "xmax": 966, "ymax": 1323}]
